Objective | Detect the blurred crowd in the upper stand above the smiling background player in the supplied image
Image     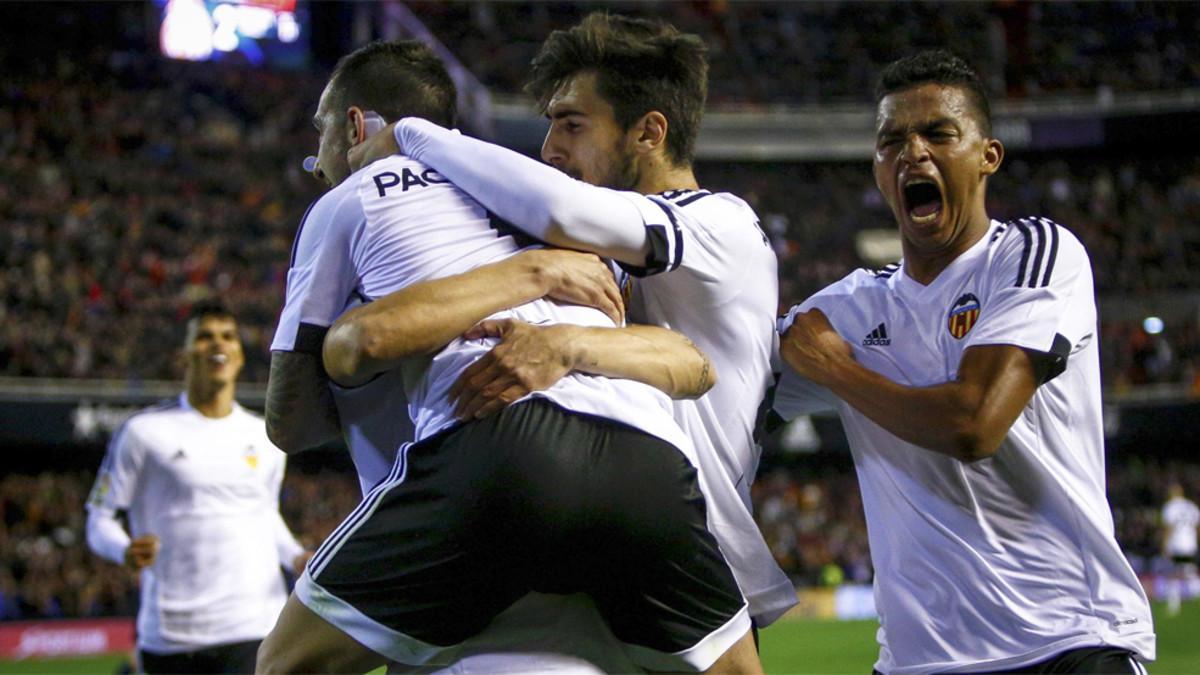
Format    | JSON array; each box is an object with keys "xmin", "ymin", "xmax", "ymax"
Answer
[{"xmin": 0, "ymin": 48, "xmax": 319, "ymax": 380}]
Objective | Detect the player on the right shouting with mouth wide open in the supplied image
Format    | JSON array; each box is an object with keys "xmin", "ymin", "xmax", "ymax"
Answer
[{"xmin": 775, "ymin": 50, "xmax": 1154, "ymax": 674}]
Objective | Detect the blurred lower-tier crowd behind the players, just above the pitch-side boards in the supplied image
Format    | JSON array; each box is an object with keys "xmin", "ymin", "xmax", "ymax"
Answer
[{"xmin": 7, "ymin": 458, "xmax": 1200, "ymax": 620}]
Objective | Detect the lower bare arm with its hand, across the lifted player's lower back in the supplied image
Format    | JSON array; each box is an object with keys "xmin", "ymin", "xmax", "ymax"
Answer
[{"xmin": 450, "ymin": 319, "xmax": 716, "ymax": 419}]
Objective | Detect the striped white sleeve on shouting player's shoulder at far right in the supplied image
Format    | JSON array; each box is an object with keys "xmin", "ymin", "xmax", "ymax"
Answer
[{"xmin": 965, "ymin": 219, "xmax": 1097, "ymax": 382}]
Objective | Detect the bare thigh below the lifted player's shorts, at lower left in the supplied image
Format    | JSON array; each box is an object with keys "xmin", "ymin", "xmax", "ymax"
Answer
[{"xmin": 254, "ymin": 596, "xmax": 385, "ymax": 673}]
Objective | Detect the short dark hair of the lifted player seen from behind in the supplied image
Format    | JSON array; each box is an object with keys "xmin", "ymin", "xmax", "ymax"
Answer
[{"xmin": 329, "ymin": 40, "xmax": 458, "ymax": 126}]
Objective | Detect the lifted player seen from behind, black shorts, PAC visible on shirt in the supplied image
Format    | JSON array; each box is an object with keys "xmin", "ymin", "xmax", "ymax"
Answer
[{"xmin": 258, "ymin": 42, "xmax": 760, "ymax": 671}]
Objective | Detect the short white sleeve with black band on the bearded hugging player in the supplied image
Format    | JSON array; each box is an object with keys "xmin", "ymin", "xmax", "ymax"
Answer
[{"xmin": 622, "ymin": 191, "xmax": 778, "ymax": 304}]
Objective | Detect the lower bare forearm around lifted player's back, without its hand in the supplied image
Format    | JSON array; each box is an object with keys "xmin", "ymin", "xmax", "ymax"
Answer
[{"xmin": 570, "ymin": 325, "xmax": 716, "ymax": 399}]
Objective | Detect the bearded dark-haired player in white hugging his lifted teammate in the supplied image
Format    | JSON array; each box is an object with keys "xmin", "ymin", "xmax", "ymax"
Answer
[{"xmin": 340, "ymin": 14, "xmax": 796, "ymax": 669}]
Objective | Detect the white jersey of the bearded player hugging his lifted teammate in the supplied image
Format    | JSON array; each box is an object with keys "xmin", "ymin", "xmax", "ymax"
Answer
[{"xmin": 623, "ymin": 190, "xmax": 797, "ymax": 627}]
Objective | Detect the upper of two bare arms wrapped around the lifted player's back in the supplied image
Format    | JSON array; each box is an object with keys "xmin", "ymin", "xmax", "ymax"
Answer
[{"xmin": 323, "ymin": 249, "xmax": 625, "ymax": 387}]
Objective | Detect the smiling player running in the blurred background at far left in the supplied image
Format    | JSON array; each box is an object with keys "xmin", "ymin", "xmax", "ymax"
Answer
[{"xmin": 88, "ymin": 304, "xmax": 307, "ymax": 673}]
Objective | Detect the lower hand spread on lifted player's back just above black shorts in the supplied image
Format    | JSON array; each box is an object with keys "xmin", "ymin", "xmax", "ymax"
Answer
[{"xmin": 450, "ymin": 318, "xmax": 575, "ymax": 419}]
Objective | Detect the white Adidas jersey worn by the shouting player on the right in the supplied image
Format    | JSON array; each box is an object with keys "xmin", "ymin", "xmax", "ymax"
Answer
[{"xmin": 775, "ymin": 219, "xmax": 1154, "ymax": 674}]
